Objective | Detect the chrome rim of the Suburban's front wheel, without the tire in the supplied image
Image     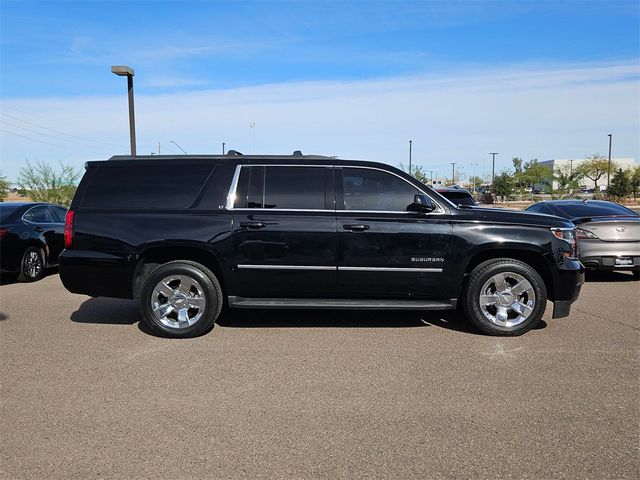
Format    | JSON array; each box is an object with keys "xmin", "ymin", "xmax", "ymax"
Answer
[{"xmin": 479, "ymin": 272, "xmax": 536, "ymax": 327}]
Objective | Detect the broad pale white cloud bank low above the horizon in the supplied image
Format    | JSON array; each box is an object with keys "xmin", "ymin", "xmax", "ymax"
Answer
[{"xmin": 0, "ymin": 62, "xmax": 640, "ymax": 178}]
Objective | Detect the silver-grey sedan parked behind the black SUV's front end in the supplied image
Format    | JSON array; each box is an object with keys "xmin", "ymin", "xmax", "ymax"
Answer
[{"xmin": 526, "ymin": 200, "xmax": 640, "ymax": 280}]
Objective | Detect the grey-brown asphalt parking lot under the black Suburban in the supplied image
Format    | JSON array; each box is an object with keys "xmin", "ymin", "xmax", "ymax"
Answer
[{"xmin": 0, "ymin": 273, "xmax": 640, "ymax": 479}]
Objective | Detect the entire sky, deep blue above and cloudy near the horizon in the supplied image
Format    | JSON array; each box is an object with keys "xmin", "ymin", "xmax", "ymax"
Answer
[{"xmin": 0, "ymin": 0, "xmax": 640, "ymax": 178}]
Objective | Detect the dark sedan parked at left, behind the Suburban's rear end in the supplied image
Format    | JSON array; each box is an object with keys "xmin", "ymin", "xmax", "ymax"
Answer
[{"xmin": 0, "ymin": 202, "xmax": 67, "ymax": 282}]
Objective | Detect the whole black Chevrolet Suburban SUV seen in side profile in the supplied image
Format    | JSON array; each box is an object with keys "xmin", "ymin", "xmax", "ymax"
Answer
[{"xmin": 60, "ymin": 152, "xmax": 584, "ymax": 337}]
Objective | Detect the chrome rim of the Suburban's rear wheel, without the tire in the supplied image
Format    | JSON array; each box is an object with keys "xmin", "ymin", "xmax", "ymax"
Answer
[{"xmin": 151, "ymin": 275, "xmax": 207, "ymax": 329}]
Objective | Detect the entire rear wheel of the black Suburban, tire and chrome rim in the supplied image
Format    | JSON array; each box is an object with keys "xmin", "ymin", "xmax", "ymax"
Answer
[{"xmin": 140, "ymin": 260, "xmax": 223, "ymax": 338}]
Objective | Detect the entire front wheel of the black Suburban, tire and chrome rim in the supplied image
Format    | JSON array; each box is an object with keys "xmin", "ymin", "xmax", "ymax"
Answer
[{"xmin": 461, "ymin": 258, "xmax": 547, "ymax": 336}]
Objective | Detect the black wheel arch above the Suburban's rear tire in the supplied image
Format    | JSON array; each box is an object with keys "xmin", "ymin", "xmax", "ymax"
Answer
[{"xmin": 132, "ymin": 245, "xmax": 225, "ymax": 298}]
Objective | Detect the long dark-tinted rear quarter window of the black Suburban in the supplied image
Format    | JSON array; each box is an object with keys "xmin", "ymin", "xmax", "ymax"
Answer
[{"xmin": 81, "ymin": 164, "xmax": 215, "ymax": 210}]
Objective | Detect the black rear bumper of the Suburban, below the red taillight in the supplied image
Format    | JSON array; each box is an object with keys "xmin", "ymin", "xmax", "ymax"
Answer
[{"xmin": 59, "ymin": 250, "xmax": 137, "ymax": 298}]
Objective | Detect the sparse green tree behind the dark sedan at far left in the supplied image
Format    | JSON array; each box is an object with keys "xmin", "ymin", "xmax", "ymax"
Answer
[{"xmin": 18, "ymin": 161, "xmax": 81, "ymax": 207}]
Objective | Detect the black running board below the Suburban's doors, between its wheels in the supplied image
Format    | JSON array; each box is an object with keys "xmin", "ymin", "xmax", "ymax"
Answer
[{"xmin": 229, "ymin": 296, "xmax": 456, "ymax": 310}]
